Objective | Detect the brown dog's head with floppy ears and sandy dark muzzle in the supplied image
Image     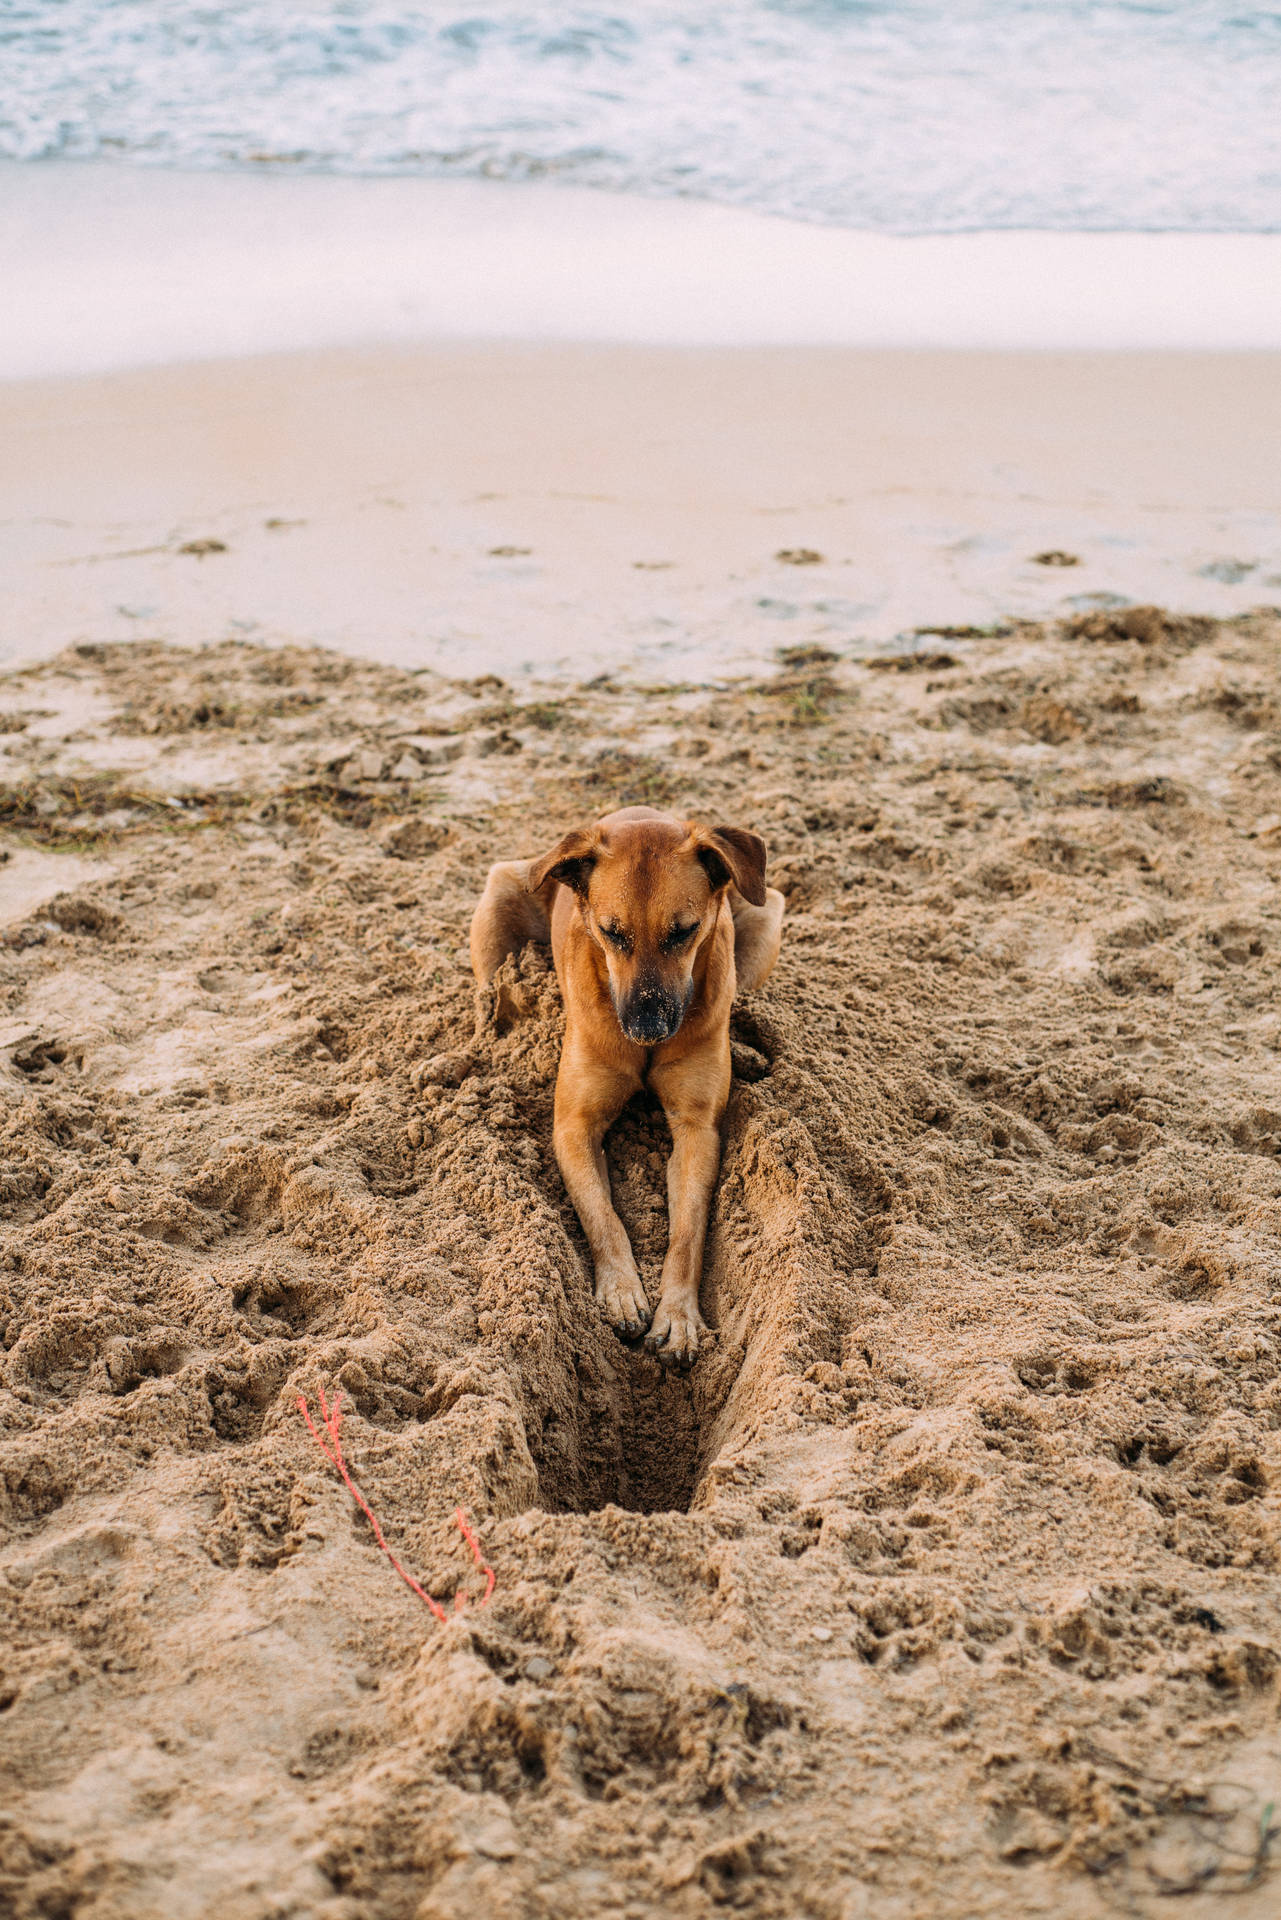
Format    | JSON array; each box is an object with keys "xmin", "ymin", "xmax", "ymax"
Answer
[{"xmin": 530, "ymin": 808, "xmax": 764, "ymax": 1046}]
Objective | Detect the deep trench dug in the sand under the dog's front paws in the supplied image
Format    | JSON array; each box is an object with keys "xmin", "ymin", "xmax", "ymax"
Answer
[{"xmin": 476, "ymin": 990, "xmax": 860, "ymax": 1515}]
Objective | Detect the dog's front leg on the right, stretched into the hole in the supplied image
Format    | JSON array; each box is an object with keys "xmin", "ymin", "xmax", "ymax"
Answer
[{"xmin": 645, "ymin": 1035, "xmax": 730, "ymax": 1367}]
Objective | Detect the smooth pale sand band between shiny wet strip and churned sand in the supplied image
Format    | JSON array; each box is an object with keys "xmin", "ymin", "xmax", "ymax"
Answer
[{"xmin": 0, "ymin": 344, "xmax": 1281, "ymax": 684}]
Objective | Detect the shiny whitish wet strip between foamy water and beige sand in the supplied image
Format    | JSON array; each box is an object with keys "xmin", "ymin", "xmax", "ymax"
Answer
[{"xmin": 0, "ymin": 161, "xmax": 1281, "ymax": 380}]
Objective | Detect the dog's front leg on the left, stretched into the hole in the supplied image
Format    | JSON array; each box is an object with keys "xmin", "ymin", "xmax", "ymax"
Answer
[{"xmin": 553, "ymin": 1043, "xmax": 651, "ymax": 1338}]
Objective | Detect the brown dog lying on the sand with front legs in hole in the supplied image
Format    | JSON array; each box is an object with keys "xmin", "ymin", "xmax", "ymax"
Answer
[{"xmin": 471, "ymin": 806, "xmax": 784, "ymax": 1365}]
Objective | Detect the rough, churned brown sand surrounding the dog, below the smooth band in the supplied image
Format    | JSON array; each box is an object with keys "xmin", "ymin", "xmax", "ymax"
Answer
[{"xmin": 0, "ymin": 611, "xmax": 1281, "ymax": 1920}]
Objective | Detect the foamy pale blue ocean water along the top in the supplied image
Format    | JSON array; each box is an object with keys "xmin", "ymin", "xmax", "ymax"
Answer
[{"xmin": 0, "ymin": 0, "xmax": 1281, "ymax": 232}]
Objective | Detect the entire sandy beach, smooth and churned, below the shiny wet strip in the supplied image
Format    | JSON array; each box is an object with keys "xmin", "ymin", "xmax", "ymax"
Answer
[{"xmin": 0, "ymin": 334, "xmax": 1281, "ymax": 1920}]
